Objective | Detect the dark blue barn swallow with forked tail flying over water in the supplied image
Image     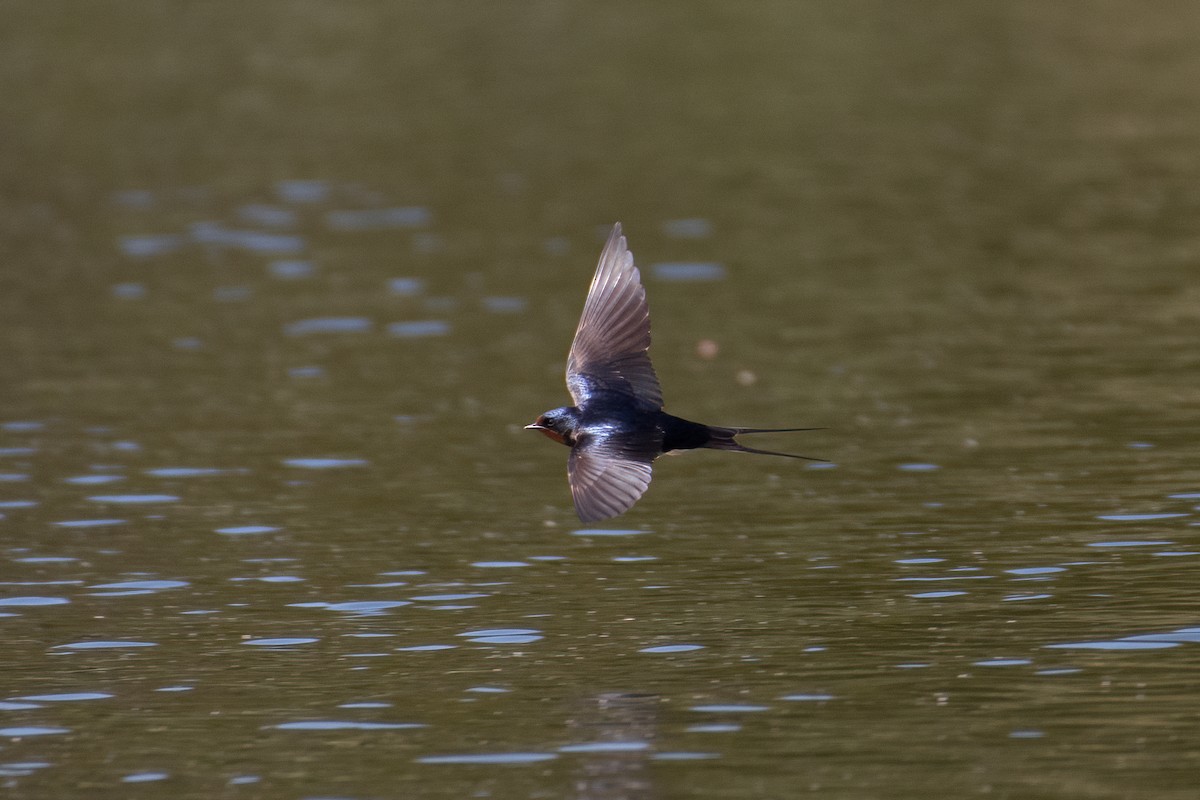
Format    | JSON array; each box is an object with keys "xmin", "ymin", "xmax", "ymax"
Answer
[{"xmin": 524, "ymin": 222, "xmax": 822, "ymax": 522}]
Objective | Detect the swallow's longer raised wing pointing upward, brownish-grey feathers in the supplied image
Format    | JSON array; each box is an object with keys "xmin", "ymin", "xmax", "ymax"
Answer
[{"xmin": 566, "ymin": 222, "xmax": 662, "ymax": 412}]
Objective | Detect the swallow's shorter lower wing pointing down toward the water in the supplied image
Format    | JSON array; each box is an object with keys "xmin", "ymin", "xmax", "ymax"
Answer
[{"xmin": 566, "ymin": 434, "xmax": 659, "ymax": 522}]
